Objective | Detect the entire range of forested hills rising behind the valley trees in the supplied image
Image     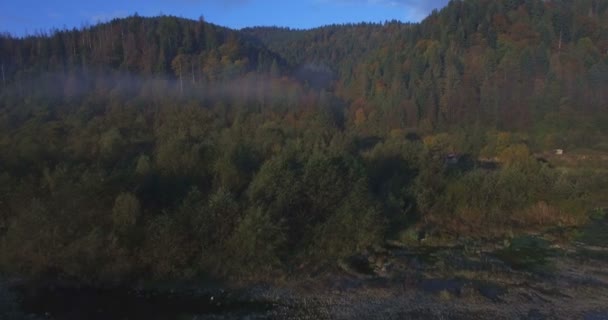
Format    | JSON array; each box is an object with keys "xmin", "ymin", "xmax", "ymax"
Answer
[{"xmin": 0, "ymin": 0, "xmax": 608, "ymax": 134}]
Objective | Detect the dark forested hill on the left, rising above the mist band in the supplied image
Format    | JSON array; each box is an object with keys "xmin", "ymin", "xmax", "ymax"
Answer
[{"xmin": 0, "ymin": 16, "xmax": 284, "ymax": 81}]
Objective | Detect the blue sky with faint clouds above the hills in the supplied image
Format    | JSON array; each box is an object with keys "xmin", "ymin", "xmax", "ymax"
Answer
[{"xmin": 0, "ymin": 0, "xmax": 448, "ymax": 36}]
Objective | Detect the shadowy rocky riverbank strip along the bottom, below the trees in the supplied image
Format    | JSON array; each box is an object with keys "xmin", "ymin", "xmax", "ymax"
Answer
[{"xmin": 0, "ymin": 216, "xmax": 608, "ymax": 320}]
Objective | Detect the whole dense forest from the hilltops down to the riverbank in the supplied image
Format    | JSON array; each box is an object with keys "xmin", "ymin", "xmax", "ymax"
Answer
[{"xmin": 0, "ymin": 0, "xmax": 608, "ymax": 281}]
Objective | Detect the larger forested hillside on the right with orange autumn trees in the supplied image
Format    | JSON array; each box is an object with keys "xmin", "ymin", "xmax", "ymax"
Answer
[{"xmin": 244, "ymin": 0, "xmax": 608, "ymax": 135}]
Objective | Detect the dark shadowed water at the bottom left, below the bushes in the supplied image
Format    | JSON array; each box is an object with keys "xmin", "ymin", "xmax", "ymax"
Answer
[{"xmin": 16, "ymin": 286, "xmax": 272, "ymax": 320}]
